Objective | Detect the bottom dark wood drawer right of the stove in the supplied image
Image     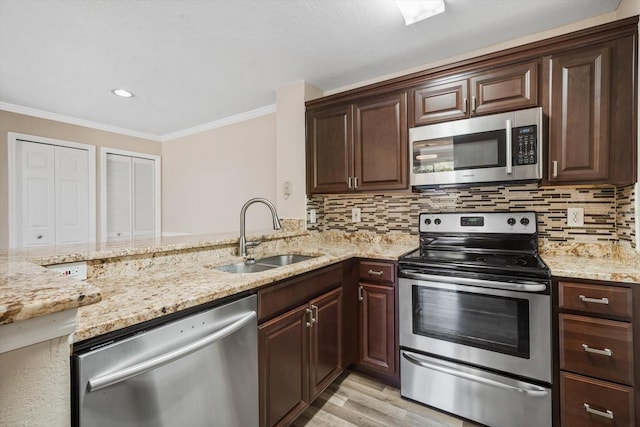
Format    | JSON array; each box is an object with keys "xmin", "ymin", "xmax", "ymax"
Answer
[{"xmin": 560, "ymin": 372, "xmax": 635, "ymax": 427}]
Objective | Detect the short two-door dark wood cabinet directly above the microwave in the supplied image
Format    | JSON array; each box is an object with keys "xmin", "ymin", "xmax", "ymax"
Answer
[{"xmin": 412, "ymin": 61, "xmax": 538, "ymax": 126}]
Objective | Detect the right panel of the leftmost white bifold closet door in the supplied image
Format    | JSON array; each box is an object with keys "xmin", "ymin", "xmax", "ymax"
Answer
[{"xmin": 54, "ymin": 147, "xmax": 89, "ymax": 244}]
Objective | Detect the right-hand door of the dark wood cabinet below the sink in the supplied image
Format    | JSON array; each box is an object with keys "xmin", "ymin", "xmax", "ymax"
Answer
[{"xmin": 309, "ymin": 287, "xmax": 343, "ymax": 401}]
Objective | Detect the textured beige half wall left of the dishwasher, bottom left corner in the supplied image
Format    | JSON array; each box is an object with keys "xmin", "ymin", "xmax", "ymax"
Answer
[{"xmin": 0, "ymin": 337, "xmax": 71, "ymax": 427}]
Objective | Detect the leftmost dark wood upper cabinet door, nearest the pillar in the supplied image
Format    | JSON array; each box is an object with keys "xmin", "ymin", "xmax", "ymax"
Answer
[{"xmin": 306, "ymin": 105, "xmax": 353, "ymax": 194}]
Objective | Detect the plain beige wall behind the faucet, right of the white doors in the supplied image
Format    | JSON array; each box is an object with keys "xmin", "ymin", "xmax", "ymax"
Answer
[{"xmin": 162, "ymin": 114, "xmax": 276, "ymax": 233}]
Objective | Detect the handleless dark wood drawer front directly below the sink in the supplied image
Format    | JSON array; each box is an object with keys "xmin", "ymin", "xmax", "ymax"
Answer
[{"xmin": 258, "ymin": 264, "xmax": 342, "ymax": 322}]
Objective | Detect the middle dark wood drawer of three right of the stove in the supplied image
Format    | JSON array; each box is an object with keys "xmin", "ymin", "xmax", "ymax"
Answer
[{"xmin": 560, "ymin": 314, "xmax": 633, "ymax": 385}]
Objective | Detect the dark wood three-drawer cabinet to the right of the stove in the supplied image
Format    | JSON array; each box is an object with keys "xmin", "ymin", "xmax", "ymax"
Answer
[{"xmin": 554, "ymin": 279, "xmax": 640, "ymax": 427}]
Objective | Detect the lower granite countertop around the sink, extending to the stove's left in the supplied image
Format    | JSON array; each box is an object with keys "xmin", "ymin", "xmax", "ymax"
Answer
[{"xmin": 74, "ymin": 239, "xmax": 417, "ymax": 342}]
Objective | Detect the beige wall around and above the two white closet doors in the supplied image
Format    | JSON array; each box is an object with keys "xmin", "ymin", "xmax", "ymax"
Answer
[{"xmin": 0, "ymin": 110, "xmax": 162, "ymax": 249}]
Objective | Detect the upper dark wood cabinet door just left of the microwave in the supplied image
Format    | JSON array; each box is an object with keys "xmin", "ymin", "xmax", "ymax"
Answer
[{"xmin": 354, "ymin": 92, "xmax": 408, "ymax": 190}]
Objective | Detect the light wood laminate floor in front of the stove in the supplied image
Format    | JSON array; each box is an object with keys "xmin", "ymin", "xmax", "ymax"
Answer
[{"xmin": 293, "ymin": 371, "xmax": 477, "ymax": 427}]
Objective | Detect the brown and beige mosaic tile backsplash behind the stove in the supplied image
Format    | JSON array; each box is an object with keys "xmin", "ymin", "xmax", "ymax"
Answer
[{"xmin": 307, "ymin": 183, "xmax": 636, "ymax": 247}]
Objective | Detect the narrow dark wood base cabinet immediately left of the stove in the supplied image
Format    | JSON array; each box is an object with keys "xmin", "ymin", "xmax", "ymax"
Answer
[{"xmin": 357, "ymin": 260, "xmax": 399, "ymax": 384}]
